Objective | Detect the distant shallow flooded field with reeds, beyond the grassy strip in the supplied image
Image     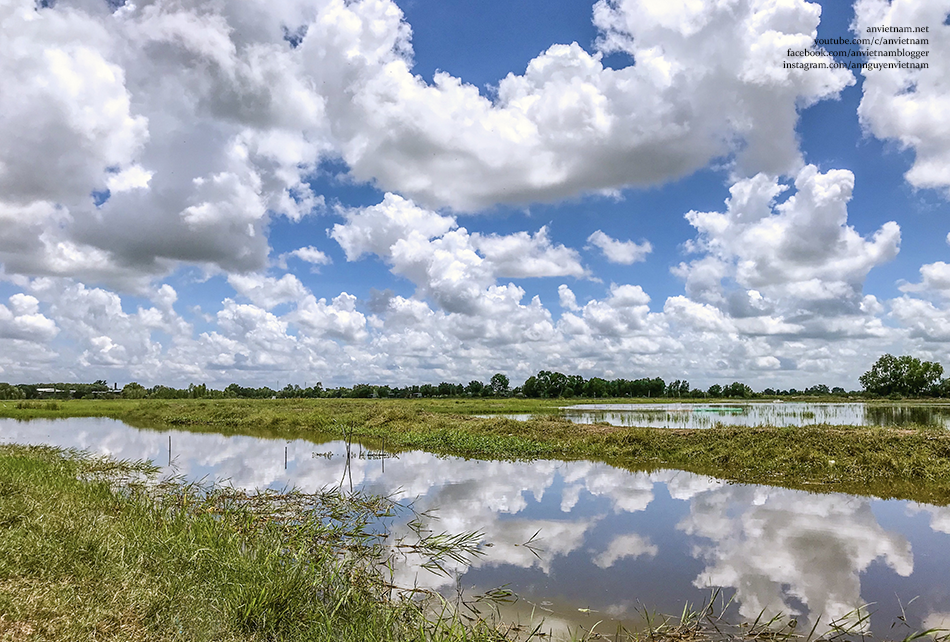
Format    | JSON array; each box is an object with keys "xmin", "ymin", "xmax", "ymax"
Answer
[{"xmin": 562, "ymin": 402, "xmax": 950, "ymax": 428}]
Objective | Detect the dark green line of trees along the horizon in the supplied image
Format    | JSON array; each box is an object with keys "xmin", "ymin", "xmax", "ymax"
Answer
[{"xmin": 0, "ymin": 354, "xmax": 950, "ymax": 399}]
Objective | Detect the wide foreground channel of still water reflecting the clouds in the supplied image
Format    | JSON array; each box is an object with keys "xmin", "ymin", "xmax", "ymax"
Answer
[{"xmin": 0, "ymin": 418, "xmax": 950, "ymax": 639}]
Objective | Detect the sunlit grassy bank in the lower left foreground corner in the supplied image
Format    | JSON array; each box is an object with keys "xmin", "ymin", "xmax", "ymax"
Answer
[{"xmin": 0, "ymin": 445, "xmax": 506, "ymax": 641}]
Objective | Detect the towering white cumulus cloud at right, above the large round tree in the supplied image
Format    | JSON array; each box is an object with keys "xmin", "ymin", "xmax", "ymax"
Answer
[{"xmin": 674, "ymin": 165, "xmax": 901, "ymax": 335}]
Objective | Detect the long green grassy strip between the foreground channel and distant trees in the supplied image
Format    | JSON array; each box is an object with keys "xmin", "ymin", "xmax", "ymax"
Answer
[{"xmin": 0, "ymin": 399, "xmax": 950, "ymax": 504}]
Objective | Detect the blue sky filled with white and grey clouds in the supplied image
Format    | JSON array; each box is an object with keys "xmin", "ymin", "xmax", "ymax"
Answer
[{"xmin": 0, "ymin": 0, "xmax": 950, "ymax": 390}]
